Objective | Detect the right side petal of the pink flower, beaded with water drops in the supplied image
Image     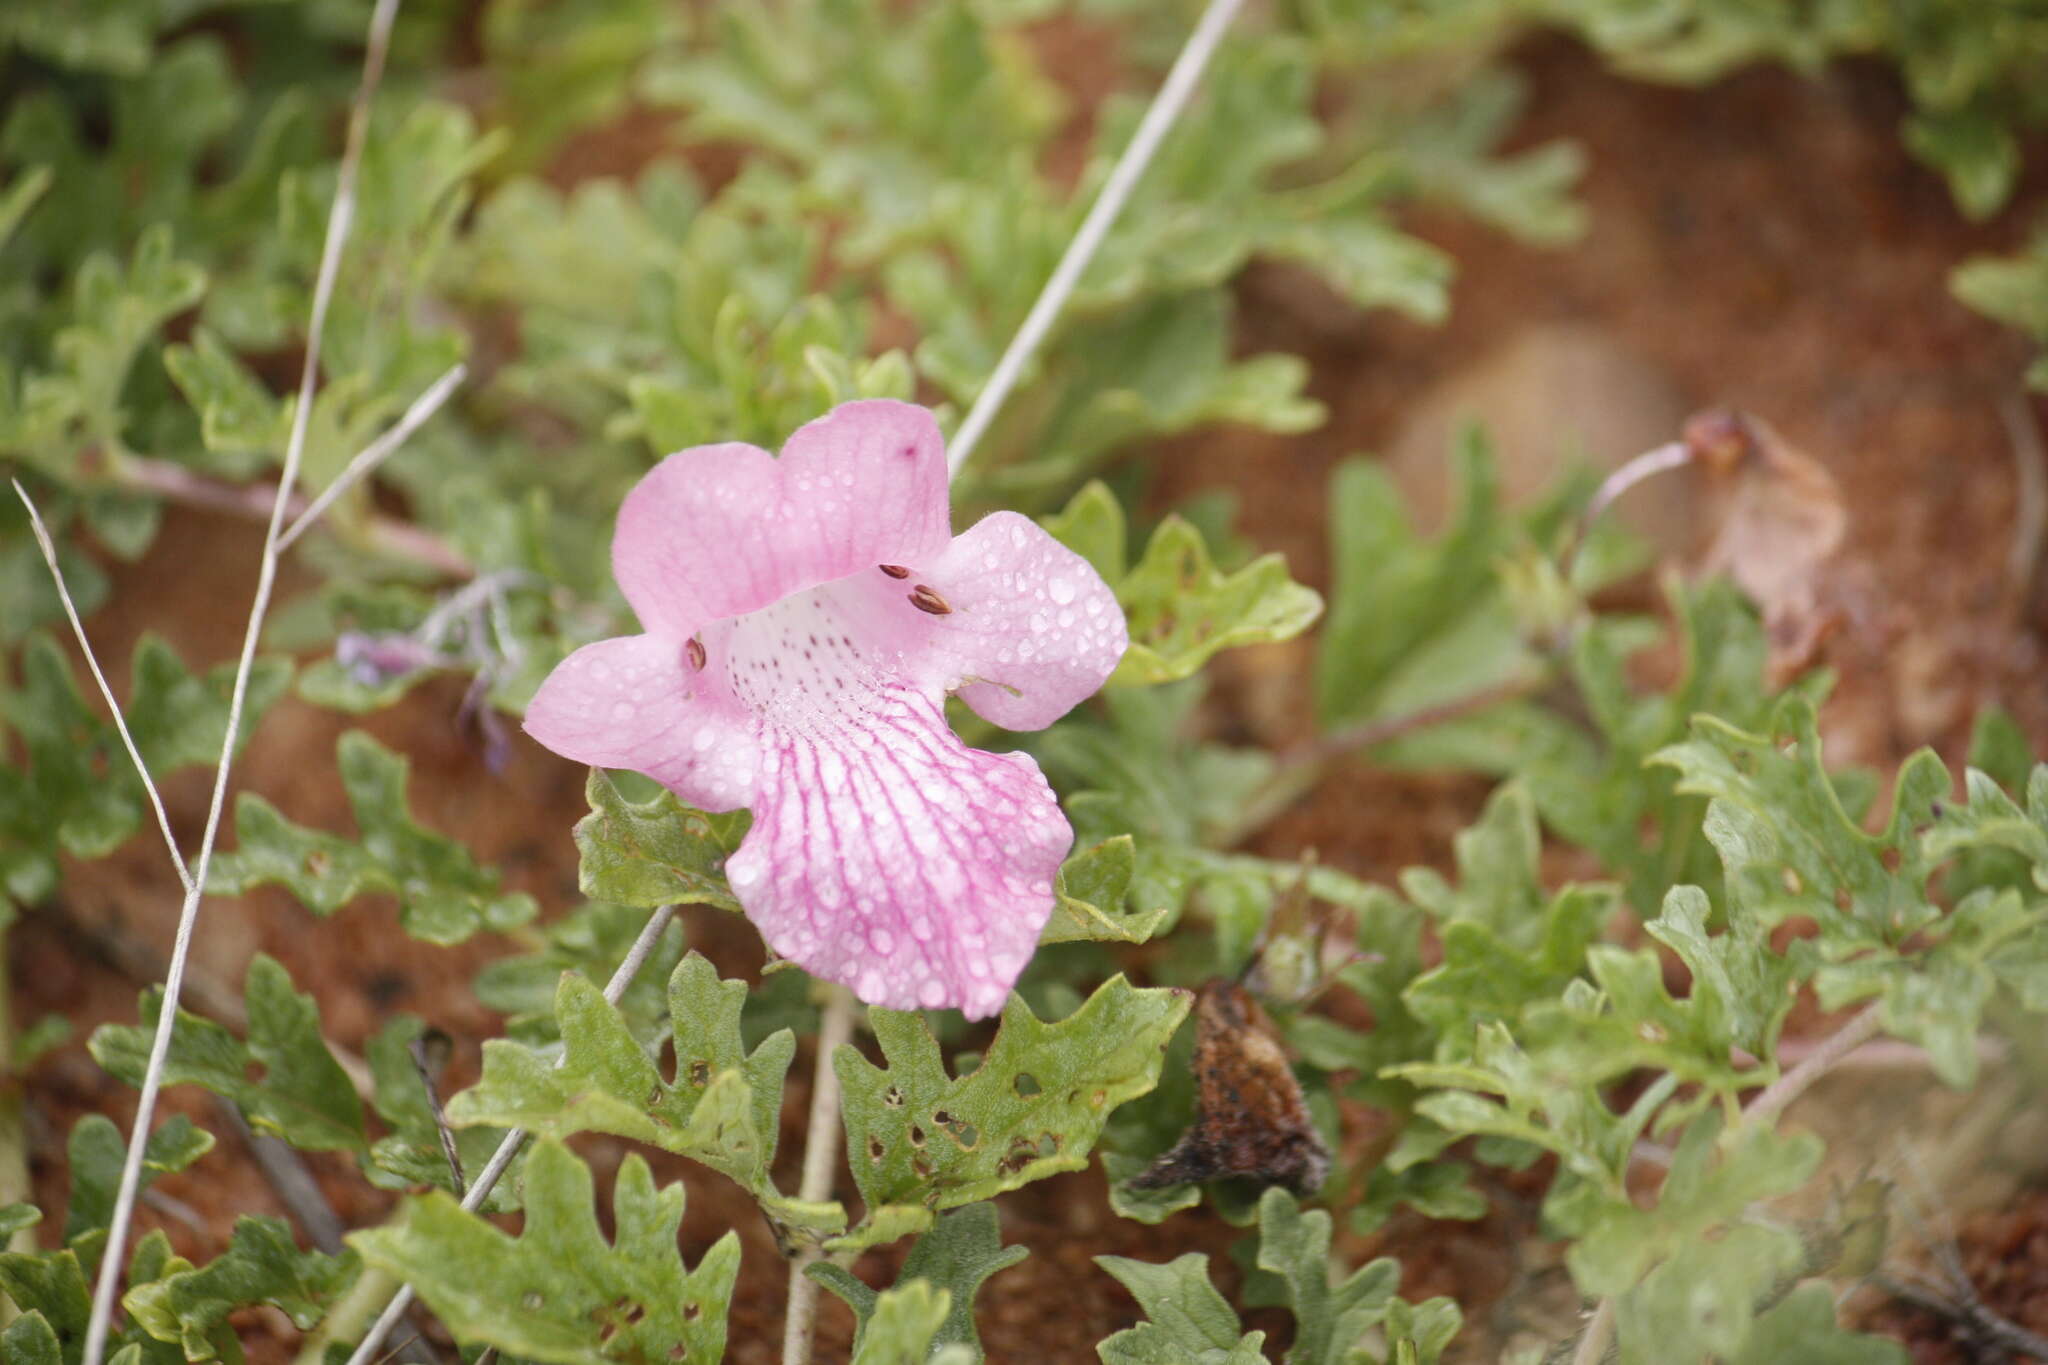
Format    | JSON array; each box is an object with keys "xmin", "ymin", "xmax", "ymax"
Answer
[{"xmin": 924, "ymin": 512, "xmax": 1130, "ymax": 731}]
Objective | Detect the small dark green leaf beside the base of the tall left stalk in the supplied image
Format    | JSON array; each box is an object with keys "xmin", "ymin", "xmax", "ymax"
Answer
[{"xmin": 121, "ymin": 1218, "xmax": 360, "ymax": 1361}]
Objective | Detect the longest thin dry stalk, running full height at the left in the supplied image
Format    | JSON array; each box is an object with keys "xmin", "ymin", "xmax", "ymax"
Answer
[{"xmin": 82, "ymin": 0, "xmax": 397, "ymax": 1365}]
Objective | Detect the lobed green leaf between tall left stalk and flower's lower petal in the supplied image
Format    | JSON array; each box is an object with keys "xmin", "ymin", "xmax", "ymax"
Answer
[{"xmin": 207, "ymin": 731, "xmax": 537, "ymax": 943}]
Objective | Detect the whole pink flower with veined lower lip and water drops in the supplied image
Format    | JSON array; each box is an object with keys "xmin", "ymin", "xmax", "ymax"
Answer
[{"xmin": 526, "ymin": 399, "xmax": 1126, "ymax": 1019}]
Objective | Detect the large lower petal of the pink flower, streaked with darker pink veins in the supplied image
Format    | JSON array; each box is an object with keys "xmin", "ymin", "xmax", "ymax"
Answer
[{"xmin": 725, "ymin": 684, "xmax": 1073, "ymax": 1019}]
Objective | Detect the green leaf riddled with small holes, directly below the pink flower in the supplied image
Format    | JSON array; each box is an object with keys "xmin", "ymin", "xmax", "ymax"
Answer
[{"xmin": 831, "ymin": 976, "xmax": 1190, "ymax": 1209}]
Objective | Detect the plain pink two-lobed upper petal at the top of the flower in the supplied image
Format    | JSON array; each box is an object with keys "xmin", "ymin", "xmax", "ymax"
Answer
[{"xmin": 612, "ymin": 399, "xmax": 948, "ymax": 636}]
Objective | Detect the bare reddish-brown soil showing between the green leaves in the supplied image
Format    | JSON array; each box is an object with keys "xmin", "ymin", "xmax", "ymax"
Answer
[{"xmin": 10, "ymin": 27, "xmax": 2048, "ymax": 1365}]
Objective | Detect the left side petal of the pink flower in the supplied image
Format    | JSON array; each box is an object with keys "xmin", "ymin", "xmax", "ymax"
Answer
[{"xmin": 526, "ymin": 634, "xmax": 760, "ymax": 810}]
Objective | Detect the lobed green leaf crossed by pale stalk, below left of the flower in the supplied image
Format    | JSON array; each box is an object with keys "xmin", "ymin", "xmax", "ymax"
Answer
[{"xmin": 449, "ymin": 952, "xmax": 797, "ymax": 1197}]
